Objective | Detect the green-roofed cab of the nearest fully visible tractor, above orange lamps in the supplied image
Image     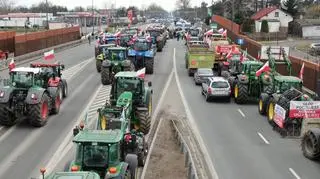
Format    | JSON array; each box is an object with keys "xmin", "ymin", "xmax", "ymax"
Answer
[{"xmin": 69, "ymin": 129, "xmax": 124, "ymax": 178}]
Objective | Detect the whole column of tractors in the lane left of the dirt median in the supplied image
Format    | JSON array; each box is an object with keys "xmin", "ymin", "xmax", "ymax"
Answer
[{"xmin": 36, "ymin": 26, "xmax": 171, "ymax": 179}]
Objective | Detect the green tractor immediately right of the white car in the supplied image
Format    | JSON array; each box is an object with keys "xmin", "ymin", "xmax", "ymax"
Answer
[{"xmin": 231, "ymin": 61, "xmax": 271, "ymax": 104}]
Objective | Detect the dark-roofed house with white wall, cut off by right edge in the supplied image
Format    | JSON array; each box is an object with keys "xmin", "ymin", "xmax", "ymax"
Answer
[{"xmin": 289, "ymin": 19, "xmax": 320, "ymax": 39}]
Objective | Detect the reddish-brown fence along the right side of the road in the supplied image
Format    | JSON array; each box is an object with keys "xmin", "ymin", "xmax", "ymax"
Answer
[{"xmin": 212, "ymin": 15, "xmax": 320, "ymax": 95}]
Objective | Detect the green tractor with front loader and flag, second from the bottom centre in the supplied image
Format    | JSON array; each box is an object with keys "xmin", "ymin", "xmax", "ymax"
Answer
[{"xmin": 104, "ymin": 72, "xmax": 152, "ymax": 135}]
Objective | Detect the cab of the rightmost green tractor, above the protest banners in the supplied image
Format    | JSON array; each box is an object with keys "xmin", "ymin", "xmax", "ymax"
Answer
[{"xmin": 273, "ymin": 75, "xmax": 303, "ymax": 94}]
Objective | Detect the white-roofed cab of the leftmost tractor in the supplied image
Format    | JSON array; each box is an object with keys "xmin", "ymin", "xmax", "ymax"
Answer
[{"xmin": 10, "ymin": 67, "xmax": 43, "ymax": 89}]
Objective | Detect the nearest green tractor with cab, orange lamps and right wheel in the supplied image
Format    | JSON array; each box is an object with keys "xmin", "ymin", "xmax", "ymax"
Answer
[{"xmin": 65, "ymin": 126, "xmax": 138, "ymax": 179}]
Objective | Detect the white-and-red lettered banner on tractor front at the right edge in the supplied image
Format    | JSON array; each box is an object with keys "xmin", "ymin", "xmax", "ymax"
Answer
[{"xmin": 289, "ymin": 101, "xmax": 320, "ymax": 119}]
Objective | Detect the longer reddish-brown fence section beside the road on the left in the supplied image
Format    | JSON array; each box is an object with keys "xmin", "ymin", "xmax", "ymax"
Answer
[{"xmin": 14, "ymin": 27, "xmax": 80, "ymax": 56}]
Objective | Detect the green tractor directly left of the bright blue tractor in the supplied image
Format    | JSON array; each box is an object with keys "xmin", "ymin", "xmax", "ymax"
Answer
[{"xmin": 101, "ymin": 47, "xmax": 135, "ymax": 85}]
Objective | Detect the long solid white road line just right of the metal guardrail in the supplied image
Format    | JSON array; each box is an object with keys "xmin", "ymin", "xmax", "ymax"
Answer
[{"xmin": 173, "ymin": 48, "xmax": 219, "ymax": 179}]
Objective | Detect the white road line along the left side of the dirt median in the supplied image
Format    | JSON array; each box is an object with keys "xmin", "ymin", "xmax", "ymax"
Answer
[{"xmin": 141, "ymin": 69, "xmax": 173, "ymax": 179}]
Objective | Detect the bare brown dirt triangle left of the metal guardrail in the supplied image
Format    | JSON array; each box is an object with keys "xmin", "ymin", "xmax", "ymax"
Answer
[{"xmin": 145, "ymin": 114, "xmax": 187, "ymax": 179}]
